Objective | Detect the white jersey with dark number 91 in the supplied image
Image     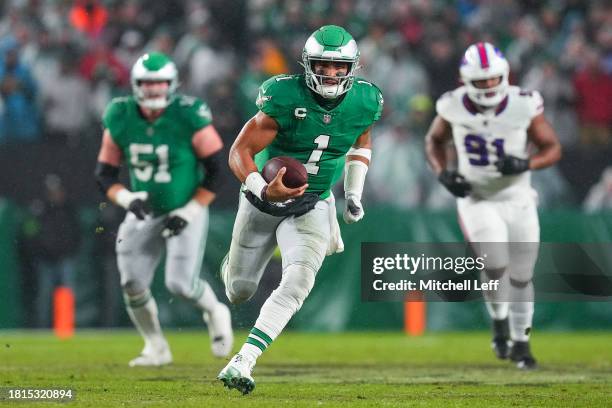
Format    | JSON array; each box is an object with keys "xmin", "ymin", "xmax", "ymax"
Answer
[{"xmin": 436, "ymin": 86, "xmax": 544, "ymax": 200}]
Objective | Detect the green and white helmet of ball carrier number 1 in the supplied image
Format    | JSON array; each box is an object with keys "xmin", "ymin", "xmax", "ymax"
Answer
[{"xmin": 302, "ymin": 25, "xmax": 359, "ymax": 99}]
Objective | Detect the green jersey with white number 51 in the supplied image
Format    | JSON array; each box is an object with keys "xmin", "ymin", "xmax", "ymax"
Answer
[{"xmin": 103, "ymin": 95, "xmax": 212, "ymax": 215}]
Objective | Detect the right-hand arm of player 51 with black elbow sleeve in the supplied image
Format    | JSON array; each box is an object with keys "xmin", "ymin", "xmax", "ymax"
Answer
[{"xmin": 191, "ymin": 125, "xmax": 223, "ymax": 206}]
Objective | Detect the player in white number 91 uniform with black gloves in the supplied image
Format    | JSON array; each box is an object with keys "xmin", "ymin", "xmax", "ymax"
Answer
[{"xmin": 426, "ymin": 42, "xmax": 561, "ymax": 369}]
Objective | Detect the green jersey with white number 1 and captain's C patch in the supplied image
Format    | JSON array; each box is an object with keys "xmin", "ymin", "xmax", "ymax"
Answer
[{"xmin": 255, "ymin": 75, "xmax": 383, "ymax": 198}]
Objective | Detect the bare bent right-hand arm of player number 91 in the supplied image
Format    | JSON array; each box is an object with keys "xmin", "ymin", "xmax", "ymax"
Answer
[{"xmin": 527, "ymin": 113, "xmax": 561, "ymax": 170}]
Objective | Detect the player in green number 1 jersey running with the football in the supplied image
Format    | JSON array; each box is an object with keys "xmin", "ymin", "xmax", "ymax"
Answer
[{"xmin": 217, "ymin": 26, "xmax": 383, "ymax": 394}]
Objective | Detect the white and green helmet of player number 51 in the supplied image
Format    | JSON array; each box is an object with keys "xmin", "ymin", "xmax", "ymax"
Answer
[{"xmin": 130, "ymin": 52, "xmax": 178, "ymax": 109}]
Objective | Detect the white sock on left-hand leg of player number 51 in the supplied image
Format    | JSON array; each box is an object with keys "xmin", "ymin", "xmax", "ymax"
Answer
[{"xmin": 124, "ymin": 290, "xmax": 168, "ymax": 348}]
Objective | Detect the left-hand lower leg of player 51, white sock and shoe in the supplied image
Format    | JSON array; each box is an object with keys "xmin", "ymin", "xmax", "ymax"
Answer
[{"xmin": 125, "ymin": 289, "xmax": 172, "ymax": 367}]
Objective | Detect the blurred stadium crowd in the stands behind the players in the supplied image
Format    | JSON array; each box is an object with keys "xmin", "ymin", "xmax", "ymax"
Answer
[{"xmin": 0, "ymin": 0, "xmax": 612, "ymax": 210}]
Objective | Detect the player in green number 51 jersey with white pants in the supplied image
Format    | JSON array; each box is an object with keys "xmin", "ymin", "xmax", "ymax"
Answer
[{"xmin": 96, "ymin": 53, "xmax": 233, "ymax": 367}]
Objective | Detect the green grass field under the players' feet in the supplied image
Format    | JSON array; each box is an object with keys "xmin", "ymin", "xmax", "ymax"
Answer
[{"xmin": 0, "ymin": 331, "xmax": 612, "ymax": 407}]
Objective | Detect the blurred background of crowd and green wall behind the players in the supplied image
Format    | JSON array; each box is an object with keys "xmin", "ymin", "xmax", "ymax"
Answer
[{"xmin": 0, "ymin": 0, "xmax": 612, "ymax": 330}]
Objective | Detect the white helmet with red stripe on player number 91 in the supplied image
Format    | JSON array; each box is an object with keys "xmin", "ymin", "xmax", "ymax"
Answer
[{"xmin": 459, "ymin": 42, "xmax": 510, "ymax": 107}]
